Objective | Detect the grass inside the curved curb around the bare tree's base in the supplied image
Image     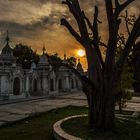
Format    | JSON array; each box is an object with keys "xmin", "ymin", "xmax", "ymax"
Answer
[{"xmin": 62, "ymin": 117, "xmax": 140, "ymax": 140}]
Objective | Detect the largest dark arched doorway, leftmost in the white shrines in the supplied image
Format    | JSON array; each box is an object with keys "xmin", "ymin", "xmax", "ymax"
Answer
[{"xmin": 13, "ymin": 77, "xmax": 20, "ymax": 95}]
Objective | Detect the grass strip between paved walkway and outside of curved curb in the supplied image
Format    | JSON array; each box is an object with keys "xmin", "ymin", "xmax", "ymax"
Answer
[{"xmin": 0, "ymin": 106, "xmax": 87, "ymax": 140}]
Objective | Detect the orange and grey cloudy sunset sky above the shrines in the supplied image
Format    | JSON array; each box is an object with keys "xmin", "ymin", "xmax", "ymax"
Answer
[{"xmin": 0, "ymin": 0, "xmax": 140, "ymax": 68}]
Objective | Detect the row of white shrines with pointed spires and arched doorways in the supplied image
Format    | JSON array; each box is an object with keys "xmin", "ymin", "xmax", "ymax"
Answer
[{"xmin": 0, "ymin": 34, "xmax": 83, "ymax": 100}]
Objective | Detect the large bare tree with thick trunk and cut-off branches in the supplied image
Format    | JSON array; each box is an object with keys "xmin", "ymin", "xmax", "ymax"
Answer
[{"xmin": 61, "ymin": 0, "xmax": 140, "ymax": 129}]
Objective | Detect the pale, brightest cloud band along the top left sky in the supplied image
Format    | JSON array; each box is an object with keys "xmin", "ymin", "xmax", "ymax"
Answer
[{"xmin": 0, "ymin": 0, "xmax": 66, "ymax": 24}]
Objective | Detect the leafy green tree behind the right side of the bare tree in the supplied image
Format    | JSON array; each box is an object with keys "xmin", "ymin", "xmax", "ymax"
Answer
[{"xmin": 116, "ymin": 34, "xmax": 134, "ymax": 113}]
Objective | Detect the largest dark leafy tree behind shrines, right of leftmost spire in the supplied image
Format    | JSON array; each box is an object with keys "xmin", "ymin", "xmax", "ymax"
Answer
[{"xmin": 13, "ymin": 44, "xmax": 39, "ymax": 69}]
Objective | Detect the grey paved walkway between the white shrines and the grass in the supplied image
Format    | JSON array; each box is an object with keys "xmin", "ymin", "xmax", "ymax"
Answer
[{"xmin": 0, "ymin": 92, "xmax": 140, "ymax": 125}]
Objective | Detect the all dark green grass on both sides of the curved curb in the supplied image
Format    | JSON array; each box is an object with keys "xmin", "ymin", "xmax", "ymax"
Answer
[{"xmin": 0, "ymin": 106, "xmax": 140, "ymax": 140}]
